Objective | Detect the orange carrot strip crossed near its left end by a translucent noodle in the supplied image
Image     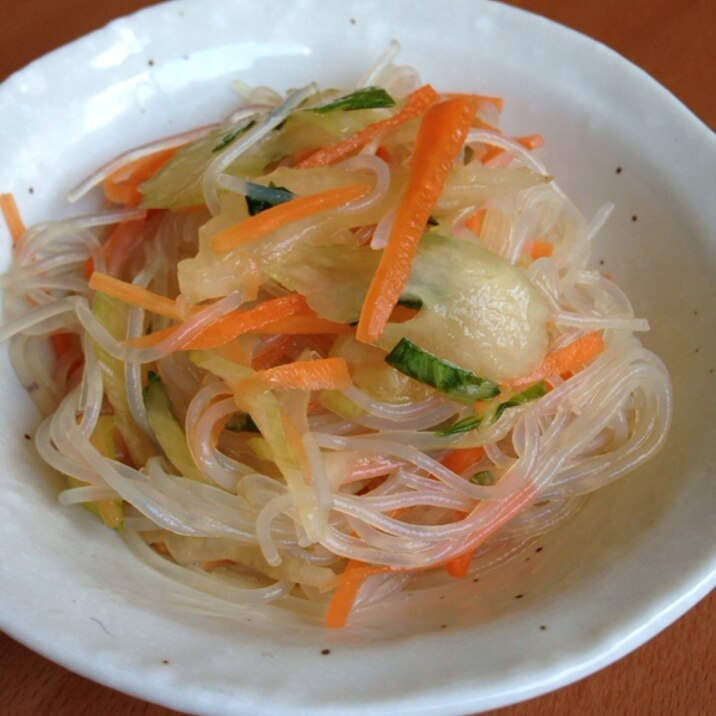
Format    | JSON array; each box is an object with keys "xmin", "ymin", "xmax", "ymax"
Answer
[{"xmin": 127, "ymin": 293, "xmax": 315, "ymax": 351}]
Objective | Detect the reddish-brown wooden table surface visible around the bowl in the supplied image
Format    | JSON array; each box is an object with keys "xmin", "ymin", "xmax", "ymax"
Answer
[{"xmin": 0, "ymin": 0, "xmax": 716, "ymax": 716}]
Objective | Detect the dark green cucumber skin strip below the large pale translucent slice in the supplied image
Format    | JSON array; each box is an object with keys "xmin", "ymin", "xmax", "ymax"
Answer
[{"xmin": 385, "ymin": 338, "xmax": 500, "ymax": 405}]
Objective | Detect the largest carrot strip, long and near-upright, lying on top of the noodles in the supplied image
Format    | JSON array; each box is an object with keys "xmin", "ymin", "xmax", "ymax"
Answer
[{"xmin": 356, "ymin": 97, "xmax": 478, "ymax": 343}]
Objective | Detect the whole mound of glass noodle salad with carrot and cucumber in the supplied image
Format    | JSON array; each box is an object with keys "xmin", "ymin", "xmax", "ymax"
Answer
[{"xmin": 0, "ymin": 43, "xmax": 671, "ymax": 627}]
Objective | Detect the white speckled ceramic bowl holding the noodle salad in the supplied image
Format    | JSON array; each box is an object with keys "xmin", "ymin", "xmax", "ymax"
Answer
[{"xmin": 0, "ymin": 0, "xmax": 716, "ymax": 716}]
